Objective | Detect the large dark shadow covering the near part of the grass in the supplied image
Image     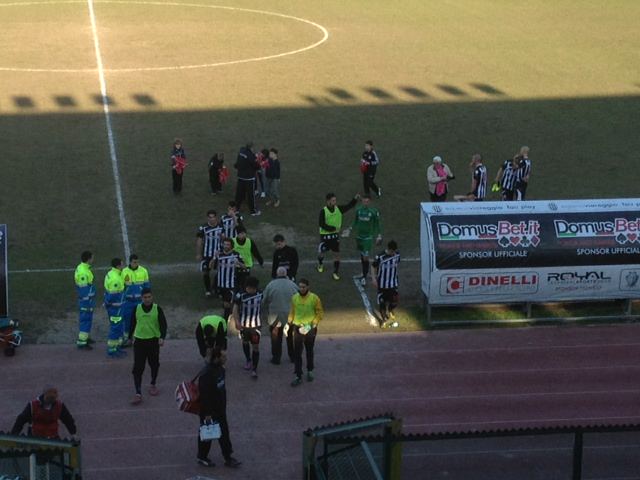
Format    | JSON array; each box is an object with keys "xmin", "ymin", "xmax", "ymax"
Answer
[{"xmin": 0, "ymin": 94, "xmax": 640, "ymax": 326}]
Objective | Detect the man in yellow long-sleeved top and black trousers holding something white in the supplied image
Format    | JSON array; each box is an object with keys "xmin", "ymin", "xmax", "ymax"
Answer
[{"xmin": 289, "ymin": 278, "xmax": 324, "ymax": 387}]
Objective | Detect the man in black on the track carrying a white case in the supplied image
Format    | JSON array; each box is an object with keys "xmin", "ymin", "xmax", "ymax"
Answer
[{"xmin": 198, "ymin": 348, "xmax": 241, "ymax": 468}]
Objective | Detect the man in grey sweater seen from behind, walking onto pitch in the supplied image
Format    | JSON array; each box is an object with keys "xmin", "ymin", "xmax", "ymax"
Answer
[{"xmin": 262, "ymin": 267, "xmax": 298, "ymax": 365}]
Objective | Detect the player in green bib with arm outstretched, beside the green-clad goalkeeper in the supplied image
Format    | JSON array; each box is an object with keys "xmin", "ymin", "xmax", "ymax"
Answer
[{"xmin": 316, "ymin": 193, "xmax": 360, "ymax": 280}]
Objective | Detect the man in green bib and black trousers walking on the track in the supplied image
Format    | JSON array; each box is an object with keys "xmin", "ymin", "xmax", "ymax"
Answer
[{"xmin": 129, "ymin": 288, "xmax": 167, "ymax": 405}]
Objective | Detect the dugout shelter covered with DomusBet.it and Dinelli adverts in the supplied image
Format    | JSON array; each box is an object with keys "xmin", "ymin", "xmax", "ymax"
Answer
[{"xmin": 421, "ymin": 199, "xmax": 640, "ymax": 304}]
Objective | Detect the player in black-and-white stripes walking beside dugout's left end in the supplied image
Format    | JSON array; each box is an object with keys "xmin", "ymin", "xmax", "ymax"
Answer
[{"xmin": 371, "ymin": 240, "xmax": 400, "ymax": 328}]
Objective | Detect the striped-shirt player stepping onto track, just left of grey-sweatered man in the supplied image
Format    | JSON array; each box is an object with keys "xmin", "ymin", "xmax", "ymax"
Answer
[{"xmin": 233, "ymin": 277, "xmax": 262, "ymax": 379}]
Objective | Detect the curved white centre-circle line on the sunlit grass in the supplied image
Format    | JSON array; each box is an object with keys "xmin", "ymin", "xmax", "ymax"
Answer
[{"xmin": 0, "ymin": 0, "xmax": 329, "ymax": 73}]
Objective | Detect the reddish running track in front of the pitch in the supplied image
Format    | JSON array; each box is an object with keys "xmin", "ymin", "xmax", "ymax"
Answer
[{"xmin": 0, "ymin": 324, "xmax": 640, "ymax": 480}]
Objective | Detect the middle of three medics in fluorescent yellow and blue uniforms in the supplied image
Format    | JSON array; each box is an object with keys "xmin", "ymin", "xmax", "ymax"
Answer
[{"xmin": 104, "ymin": 258, "xmax": 127, "ymax": 358}]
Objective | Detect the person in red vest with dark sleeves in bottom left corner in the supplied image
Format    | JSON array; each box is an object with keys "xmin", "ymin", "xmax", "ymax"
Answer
[{"xmin": 11, "ymin": 386, "xmax": 76, "ymax": 438}]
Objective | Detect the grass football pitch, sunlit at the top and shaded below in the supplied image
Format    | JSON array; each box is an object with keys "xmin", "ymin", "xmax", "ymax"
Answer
[{"xmin": 0, "ymin": 0, "xmax": 640, "ymax": 341}]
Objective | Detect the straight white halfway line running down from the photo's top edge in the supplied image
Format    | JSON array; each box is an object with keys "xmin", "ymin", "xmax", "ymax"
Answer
[{"xmin": 87, "ymin": 0, "xmax": 131, "ymax": 258}]
